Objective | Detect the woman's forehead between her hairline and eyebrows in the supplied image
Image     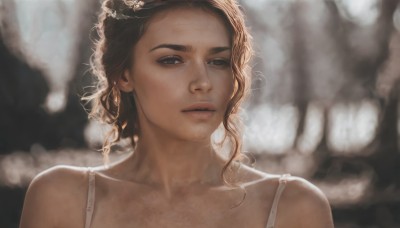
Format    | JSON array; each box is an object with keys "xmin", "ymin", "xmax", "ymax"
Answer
[{"xmin": 139, "ymin": 7, "xmax": 230, "ymax": 46}]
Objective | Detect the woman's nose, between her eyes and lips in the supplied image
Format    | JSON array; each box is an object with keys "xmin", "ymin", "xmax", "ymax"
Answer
[{"xmin": 189, "ymin": 63, "xmax": 212, "ymax": 93}]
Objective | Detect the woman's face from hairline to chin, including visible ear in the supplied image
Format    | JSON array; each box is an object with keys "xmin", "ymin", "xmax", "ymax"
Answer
[{"xmin": 119, "ymin": 8, "xmax": 234, "ymax": 141}]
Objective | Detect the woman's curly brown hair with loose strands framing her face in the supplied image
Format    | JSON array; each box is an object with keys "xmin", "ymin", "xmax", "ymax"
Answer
[{"xmin": 85, "ymin": 0, "xmax": 253, "ymax": 183}]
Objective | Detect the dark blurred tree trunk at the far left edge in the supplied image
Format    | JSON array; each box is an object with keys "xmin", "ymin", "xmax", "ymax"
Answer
[{"xmin": 0, "ymin": 0, "xmax": 49, "ymax": 154}]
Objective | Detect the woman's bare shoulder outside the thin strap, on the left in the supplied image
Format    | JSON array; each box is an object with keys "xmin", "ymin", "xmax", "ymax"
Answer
[{"xmin": 21, "ymin": 166, "xmax": 87, "ymax": 228}]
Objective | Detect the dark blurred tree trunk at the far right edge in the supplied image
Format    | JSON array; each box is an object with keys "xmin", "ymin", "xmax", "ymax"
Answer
[{"xmin": 366, "ymin": 0, "xmax": 400, "ymax": 191}]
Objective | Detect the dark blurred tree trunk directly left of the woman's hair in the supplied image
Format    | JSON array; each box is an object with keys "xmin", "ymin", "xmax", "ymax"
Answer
[{"xmin": 47, "ymin": 0, "xmax": 100, "ymax": 150}]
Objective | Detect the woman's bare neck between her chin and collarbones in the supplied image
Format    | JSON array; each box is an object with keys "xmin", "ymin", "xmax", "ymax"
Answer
[{"xmin": 126, "ymin": 134, "xmax": 223, "ymax": 197}]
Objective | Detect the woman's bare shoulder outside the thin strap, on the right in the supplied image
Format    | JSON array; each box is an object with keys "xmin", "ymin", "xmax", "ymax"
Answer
[{"xmin": 278, "ymin": 177, "xmax": 333, "ymax": 228}]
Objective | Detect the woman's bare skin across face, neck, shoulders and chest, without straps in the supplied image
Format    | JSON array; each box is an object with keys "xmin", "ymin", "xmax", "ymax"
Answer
[{"xmin": 20, "ymin": 5, "xmax": 333, "ymax": 228}]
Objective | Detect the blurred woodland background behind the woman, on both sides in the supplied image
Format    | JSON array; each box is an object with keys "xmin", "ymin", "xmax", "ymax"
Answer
[{"xmin": 0, "ymin": 0, "xmax": 400, "ymax": 228}]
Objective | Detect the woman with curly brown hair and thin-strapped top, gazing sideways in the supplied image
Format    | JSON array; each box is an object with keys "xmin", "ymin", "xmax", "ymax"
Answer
[{"xmin": 21, "ymin": 0, "xmax": 333, "ymax": 228}]
